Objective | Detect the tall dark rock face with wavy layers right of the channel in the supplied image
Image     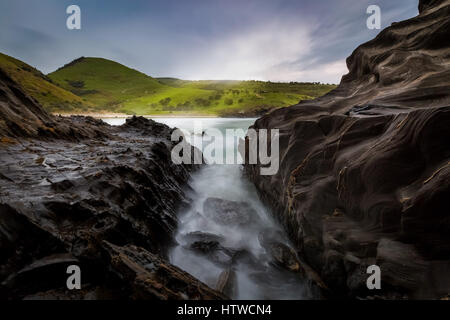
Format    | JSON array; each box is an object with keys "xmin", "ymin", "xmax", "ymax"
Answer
[{"xmin": 245, "ymin": 0, "xmax": 450, "ymax": 298}]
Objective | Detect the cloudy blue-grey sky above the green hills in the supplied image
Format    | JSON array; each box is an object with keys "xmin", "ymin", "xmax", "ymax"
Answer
[{"xmin": 0, "ymin": 0, "xmax": 418, "ymax": 83}]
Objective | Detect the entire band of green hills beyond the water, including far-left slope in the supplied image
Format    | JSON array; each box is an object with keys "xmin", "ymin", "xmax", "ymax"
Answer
[{"xmin": 0, "ymin": 54, "xmax": 335, "ymax": 116}]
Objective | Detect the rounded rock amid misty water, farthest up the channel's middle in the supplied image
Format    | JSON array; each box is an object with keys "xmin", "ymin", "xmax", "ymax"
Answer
[{"xmin": 203, "ymin": 198, "xmax": 259, "ymax": 226}]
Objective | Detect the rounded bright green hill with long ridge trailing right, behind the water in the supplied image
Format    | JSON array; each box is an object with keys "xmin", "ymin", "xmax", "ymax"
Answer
[{"xmin": 48, "ymin": 57, "xmax": 335, "ymax": 116}]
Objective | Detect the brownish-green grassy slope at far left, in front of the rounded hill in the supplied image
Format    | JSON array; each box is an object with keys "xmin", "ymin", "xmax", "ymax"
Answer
[{"xmin": 0, "ymin": 53, "xmax": 91, "ymax": 112}]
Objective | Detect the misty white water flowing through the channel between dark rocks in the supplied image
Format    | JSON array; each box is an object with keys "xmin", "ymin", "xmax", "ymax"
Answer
[{"xmin": 104, "ymin": 118, "xmax": 311, "ymax": 299}]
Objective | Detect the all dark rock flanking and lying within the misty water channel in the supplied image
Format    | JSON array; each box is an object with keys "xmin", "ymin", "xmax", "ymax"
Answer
[{"xmin": 0, "ymin": 0, "xmax": 450, "ymax": 299}]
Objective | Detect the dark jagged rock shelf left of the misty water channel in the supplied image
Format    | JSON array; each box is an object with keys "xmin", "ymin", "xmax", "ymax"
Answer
[{"xmin": 0, "ymin": 70, "xmax": 224, "ymax": 299}]
